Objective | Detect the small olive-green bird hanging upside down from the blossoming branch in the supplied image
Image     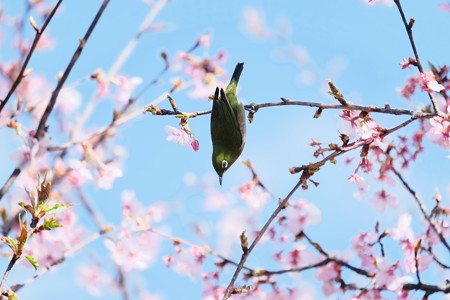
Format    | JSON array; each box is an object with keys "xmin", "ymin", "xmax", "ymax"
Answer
[{"xmin": 211, "ymin": 63, "xmax": 245, "ymax": 185}]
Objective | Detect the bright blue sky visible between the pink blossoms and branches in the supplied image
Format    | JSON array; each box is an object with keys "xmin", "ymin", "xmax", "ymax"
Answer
[{"xmin": 0, "ymin": 0, "xmax": 450, "ymax": 299}]
